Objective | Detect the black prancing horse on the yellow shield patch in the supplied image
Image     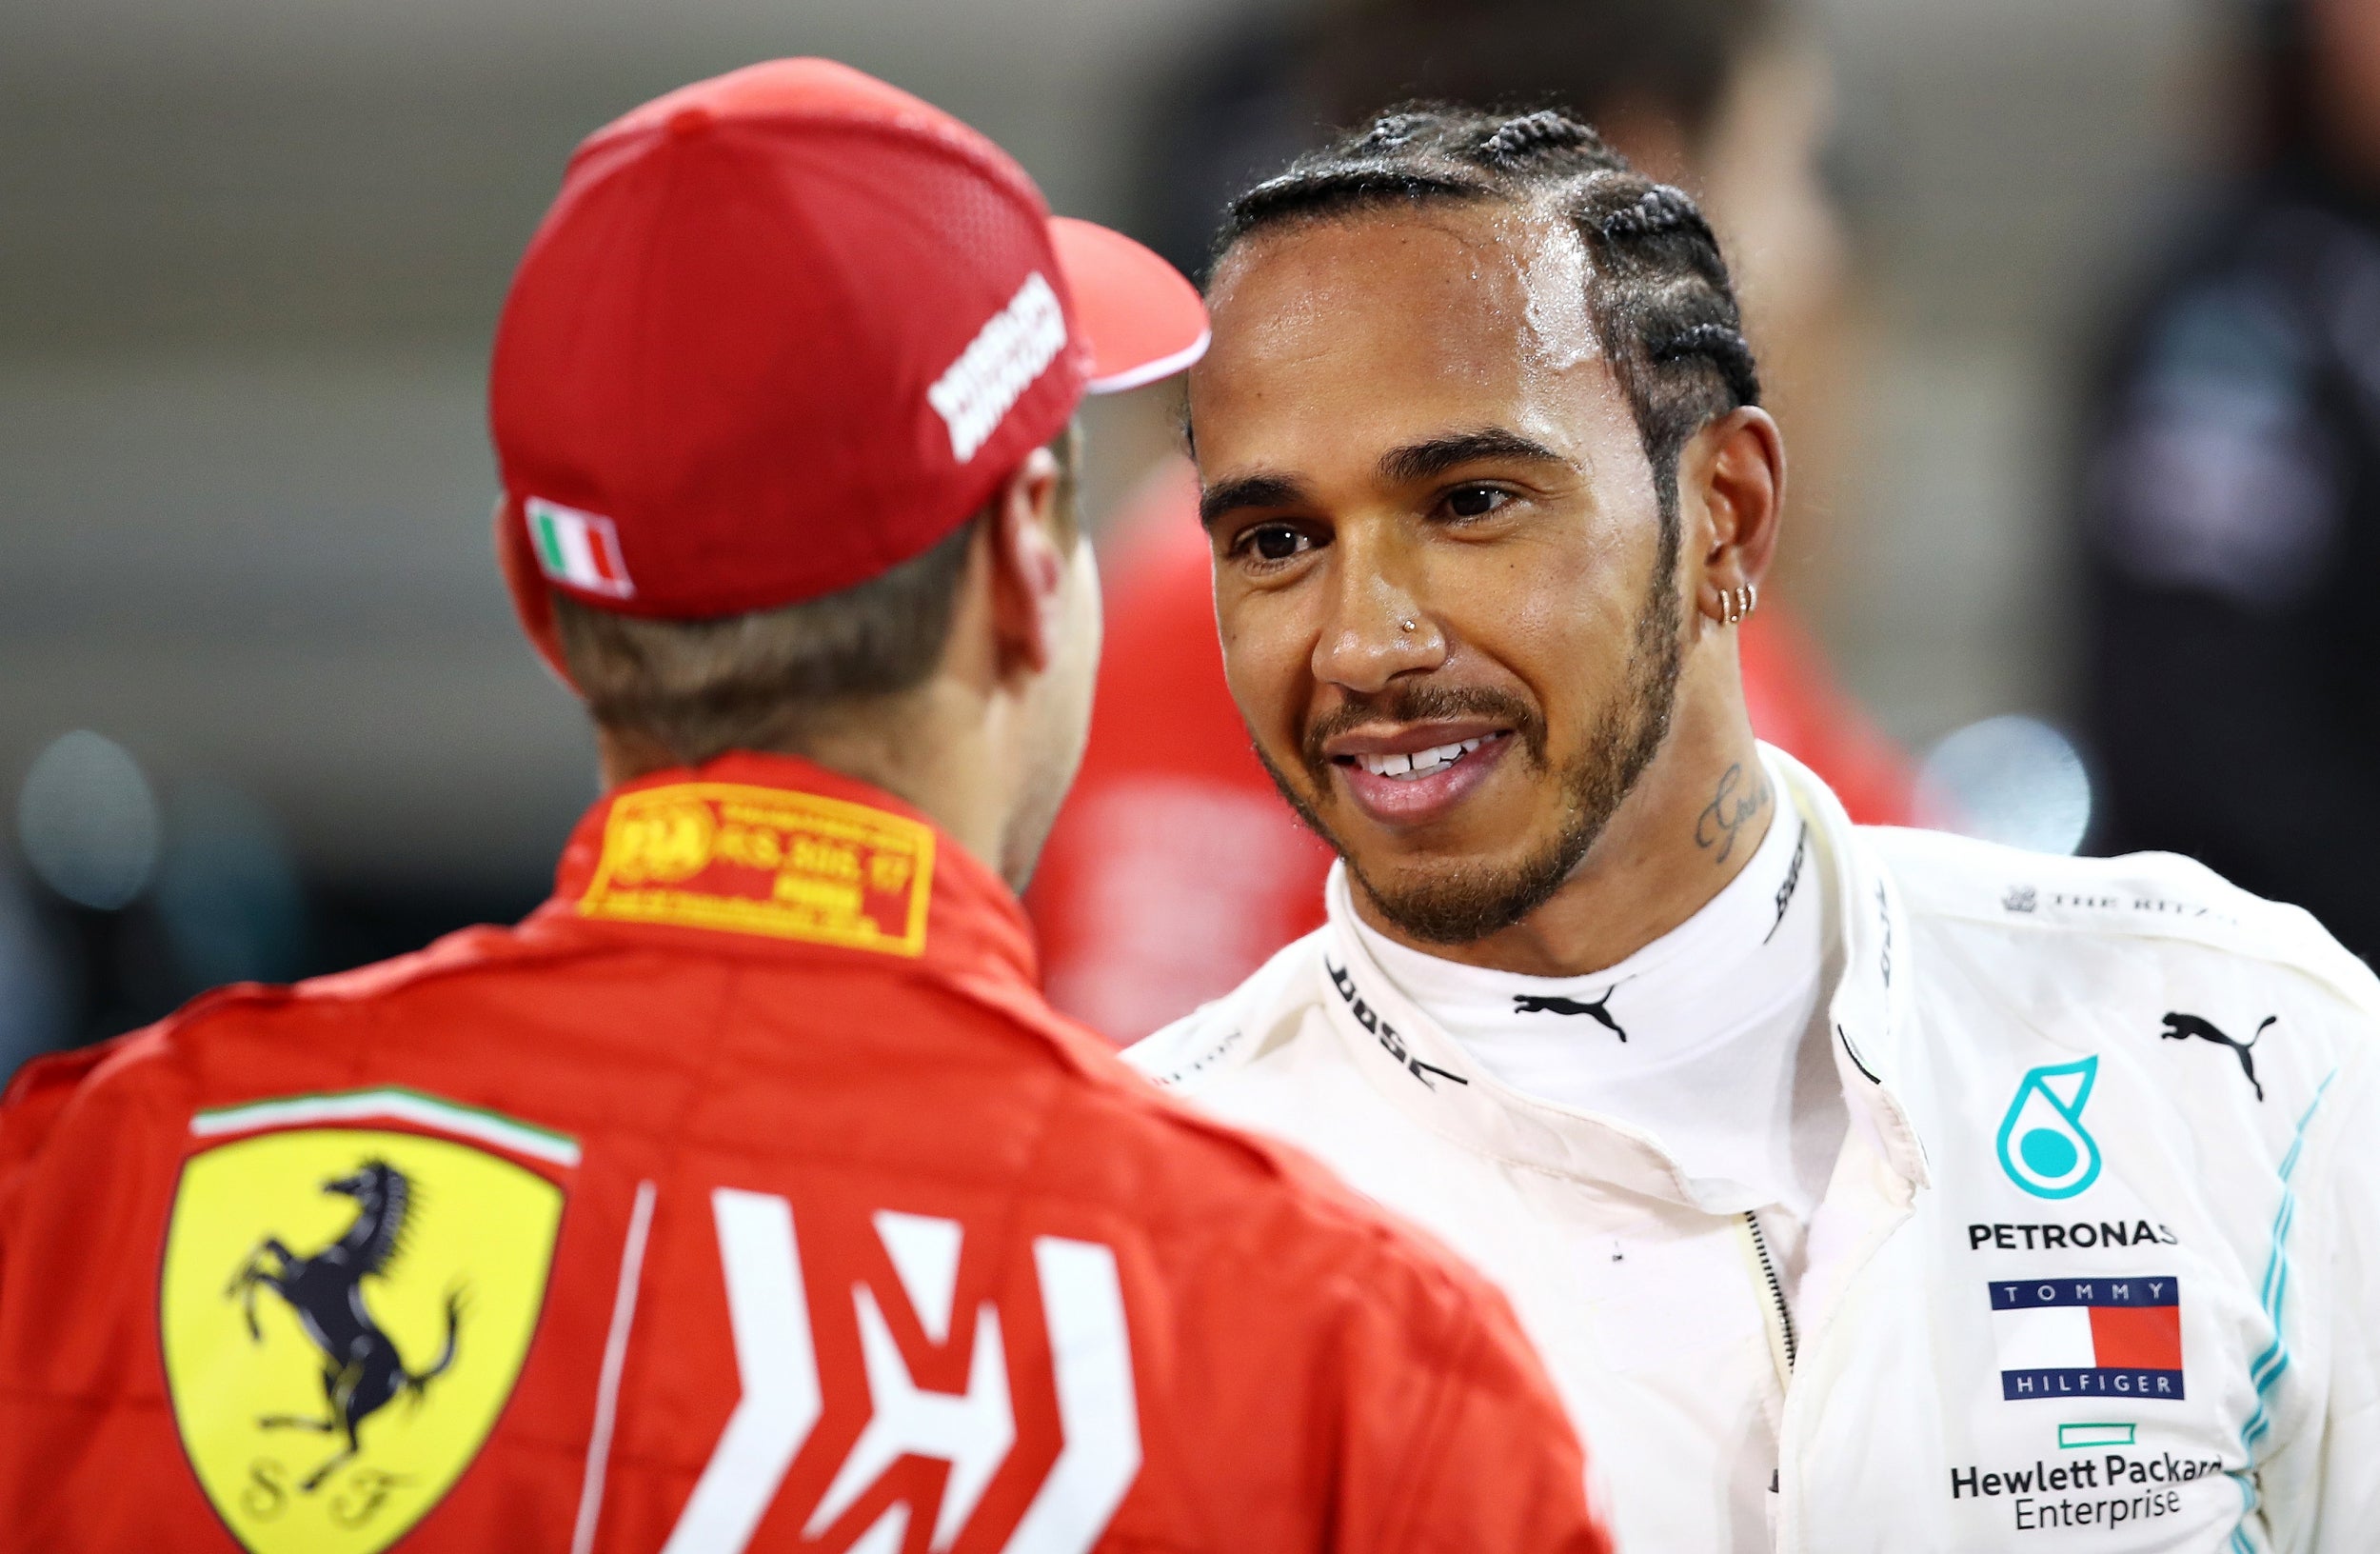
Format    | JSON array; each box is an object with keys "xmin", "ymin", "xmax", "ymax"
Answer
[{"xmin": 224, "ymin": 1159, "xmax": 465, "ymax": 1492}]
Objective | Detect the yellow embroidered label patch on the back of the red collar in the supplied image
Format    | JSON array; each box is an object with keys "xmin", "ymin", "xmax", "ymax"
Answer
[{"xmin": 579, "ymin": 783, "xmax": 933, "ymax": 954}]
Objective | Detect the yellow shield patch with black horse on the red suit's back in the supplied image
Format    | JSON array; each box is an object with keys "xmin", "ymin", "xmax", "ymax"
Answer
[{"xmin": 160, "ymin": 1128, "xmax": 562, "ymax": 1554}]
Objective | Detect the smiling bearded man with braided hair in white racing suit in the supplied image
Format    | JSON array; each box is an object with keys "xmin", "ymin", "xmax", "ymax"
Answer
[{"xmin": 1131, "ymin": 107, "xmax": 2380, "ymax": 1554}]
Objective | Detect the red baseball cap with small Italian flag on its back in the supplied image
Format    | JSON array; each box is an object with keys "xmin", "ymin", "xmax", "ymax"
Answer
[{"xmin": 488, "ymin": 59, "xmax": 1207, "ymax": 668}]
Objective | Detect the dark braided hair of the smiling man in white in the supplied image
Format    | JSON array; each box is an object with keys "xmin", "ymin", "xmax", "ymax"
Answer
[{"xmin": 1214, "ymin": 102, "xmax": 1761, "ymax": 528}]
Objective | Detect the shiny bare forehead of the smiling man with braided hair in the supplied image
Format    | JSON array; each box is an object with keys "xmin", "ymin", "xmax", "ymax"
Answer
[{"xmin": 1190, "ymin": 202, "xmax": 1626, "ymax": 464}]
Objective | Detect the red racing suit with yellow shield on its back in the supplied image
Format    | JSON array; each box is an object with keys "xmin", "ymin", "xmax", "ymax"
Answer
[{"xmin": 0, "ymin": 754, "xmax": 1607, "ymax": 1554}]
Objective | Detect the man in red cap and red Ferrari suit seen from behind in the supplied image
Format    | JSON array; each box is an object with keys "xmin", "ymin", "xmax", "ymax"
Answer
[{"xmin": 0, "ymin": 59, "xmax": 1609, "ymax": 1554}]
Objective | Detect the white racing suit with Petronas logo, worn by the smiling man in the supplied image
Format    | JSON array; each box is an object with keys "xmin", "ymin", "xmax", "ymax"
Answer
[{"xmin": 1128, "ymin": 752, "xmax": 2380, "ymax": 1554}]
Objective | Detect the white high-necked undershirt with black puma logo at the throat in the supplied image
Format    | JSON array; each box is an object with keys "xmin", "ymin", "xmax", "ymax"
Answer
[{"xmin": 1355, "ymin": 773, "xmax": 1850, "ymax": 1240}]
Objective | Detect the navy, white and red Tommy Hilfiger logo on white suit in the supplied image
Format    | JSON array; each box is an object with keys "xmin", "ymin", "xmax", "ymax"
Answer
[{"xmin": 1990, "ymin": 1273, "xmax": 2183, "ymax": 1402}]
